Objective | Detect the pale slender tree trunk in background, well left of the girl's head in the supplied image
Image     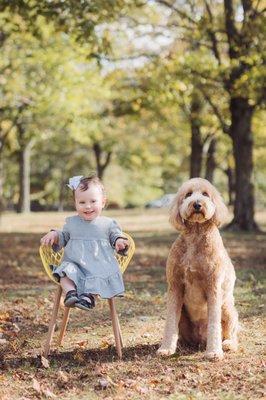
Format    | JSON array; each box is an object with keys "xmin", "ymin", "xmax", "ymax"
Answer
[{"xmin": 18, "ymin": 142, "xmax": 32, "ymax": 213}]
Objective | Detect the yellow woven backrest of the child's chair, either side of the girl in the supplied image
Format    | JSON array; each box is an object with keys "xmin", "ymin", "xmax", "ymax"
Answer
[{"xmin": 39, "ymin": 232, "xmax": 135, "ymax": 284}]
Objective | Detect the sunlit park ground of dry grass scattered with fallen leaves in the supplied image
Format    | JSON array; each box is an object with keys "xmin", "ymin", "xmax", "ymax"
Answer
[{"xmin": 0, "ymin": 210, "xmax": 266, "ymax": 400}]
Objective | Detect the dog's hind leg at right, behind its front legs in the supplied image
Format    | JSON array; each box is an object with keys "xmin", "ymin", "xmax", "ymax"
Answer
[{"xmin": 222, "ymin": 299, "xmax": 238, "ymax": 351}]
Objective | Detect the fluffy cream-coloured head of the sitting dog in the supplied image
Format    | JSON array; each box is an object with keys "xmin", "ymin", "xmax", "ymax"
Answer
[{"xmin": 170, "ymin": 178, "xmax": 228, "ymax": 230}]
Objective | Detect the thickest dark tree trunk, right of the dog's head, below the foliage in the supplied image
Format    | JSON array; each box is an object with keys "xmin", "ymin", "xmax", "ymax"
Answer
[{"xmin": 228, "ymin": 97, "xmax": 258, "ymax": 231}]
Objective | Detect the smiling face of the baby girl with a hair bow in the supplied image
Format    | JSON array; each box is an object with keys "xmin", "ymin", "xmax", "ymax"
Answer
[{"xmin": 75, "ymin": 185, "xmax": 105, "ymax": 221}]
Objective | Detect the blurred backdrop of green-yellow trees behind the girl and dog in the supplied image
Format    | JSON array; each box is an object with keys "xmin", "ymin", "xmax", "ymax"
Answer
[{"xmin": 0, "ymin": 0, "xmax": 266, "ymax": 230}]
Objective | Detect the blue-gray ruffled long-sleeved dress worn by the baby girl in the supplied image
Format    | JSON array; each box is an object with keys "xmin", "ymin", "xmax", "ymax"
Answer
[{"xmin": 53, "ymin": 215, "xmax": 125, "ymax": 299}]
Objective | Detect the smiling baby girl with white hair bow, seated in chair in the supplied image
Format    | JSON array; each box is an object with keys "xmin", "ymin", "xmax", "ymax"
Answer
[{"xmin": 41, "ymin": 176, "xmax": 128, "ymax": 310}]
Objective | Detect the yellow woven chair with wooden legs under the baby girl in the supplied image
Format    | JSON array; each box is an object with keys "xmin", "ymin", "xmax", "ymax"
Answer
[{"xmin": 40, "ymin": 233, "xmax": 135, "ymax": 358}]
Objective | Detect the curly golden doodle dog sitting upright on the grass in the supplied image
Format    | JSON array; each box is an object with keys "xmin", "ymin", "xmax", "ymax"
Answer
[{"xmin": 158, "ymin": 178, "xmax": 238, "ymax": 360}]
